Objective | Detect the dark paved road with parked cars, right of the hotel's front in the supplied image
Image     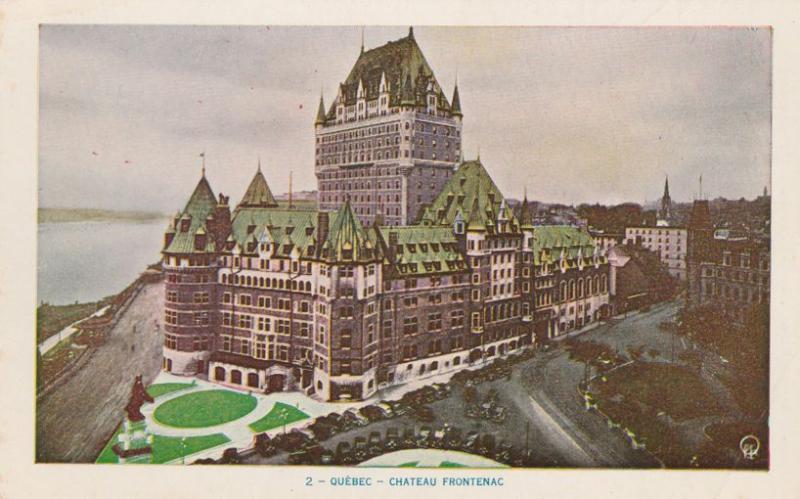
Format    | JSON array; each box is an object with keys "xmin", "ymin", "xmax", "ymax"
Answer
[{"xmin": 247, "ymin": 303, "xmax": 678, "ymax": 468}]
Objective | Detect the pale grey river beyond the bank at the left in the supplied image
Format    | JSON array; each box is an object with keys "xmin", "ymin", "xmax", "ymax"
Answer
[{"xmin": 37, "ymin": 219, "xmax": 168, "ymax": 305}]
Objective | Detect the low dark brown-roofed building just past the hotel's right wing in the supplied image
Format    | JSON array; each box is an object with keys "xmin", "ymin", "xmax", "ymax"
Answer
[{"xmin": 608, "ymin": 243, "xmax": 676, "ymax": 314}]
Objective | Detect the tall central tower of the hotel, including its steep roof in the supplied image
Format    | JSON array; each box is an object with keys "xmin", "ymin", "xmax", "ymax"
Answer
[{"xmin": 314, "ymin": 28, "xmax": 462, "ymax": 225}]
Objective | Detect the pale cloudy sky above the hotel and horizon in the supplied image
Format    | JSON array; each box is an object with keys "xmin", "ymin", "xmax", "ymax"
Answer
[{"xmin": 39, "ymin": 25, "xmax": 772, "ymax": 213}]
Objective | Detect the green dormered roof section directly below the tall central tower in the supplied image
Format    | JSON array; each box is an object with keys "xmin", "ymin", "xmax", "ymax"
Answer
[{"xmin": 378, "ymin": 226, "xmax": 467, "ymax": 276}]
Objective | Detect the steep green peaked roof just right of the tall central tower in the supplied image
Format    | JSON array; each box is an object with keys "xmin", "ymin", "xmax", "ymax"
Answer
[{"xmin": 421, "ymin": 160, "xmax": 519, "ymax": 237}]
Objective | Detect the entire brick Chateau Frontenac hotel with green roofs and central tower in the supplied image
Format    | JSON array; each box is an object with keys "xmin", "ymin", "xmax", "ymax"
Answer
[{"xmin": 163, "ymin": 31, "xmax": 609, "ymax": 400}]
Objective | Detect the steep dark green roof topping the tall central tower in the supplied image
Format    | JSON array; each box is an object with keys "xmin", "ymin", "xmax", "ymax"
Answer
[{"xmin": 327, "ymin": 30, "xmax": 450, "ymax": 116}]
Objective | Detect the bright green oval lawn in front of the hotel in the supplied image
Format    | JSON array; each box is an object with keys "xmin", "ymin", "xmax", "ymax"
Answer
[{"xmin": 153, "ymin": 390, "xmax": 258, "ymax": 428}]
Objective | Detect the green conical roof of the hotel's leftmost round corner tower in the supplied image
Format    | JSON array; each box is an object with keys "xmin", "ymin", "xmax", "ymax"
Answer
[{"xmin": 164, "ymin": 175, "xmax": 217, "ymax": 253}]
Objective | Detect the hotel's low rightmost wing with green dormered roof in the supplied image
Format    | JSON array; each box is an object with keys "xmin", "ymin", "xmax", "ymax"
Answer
[{"xmin": 533, "ymin": 226, "xmax": 610, "ymax": 340}]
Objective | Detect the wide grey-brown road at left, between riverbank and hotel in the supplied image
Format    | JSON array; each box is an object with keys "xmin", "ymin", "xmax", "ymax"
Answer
[{"xmin": 36, "ymin": 284, "xmax": 164, "ymax": 462}]
